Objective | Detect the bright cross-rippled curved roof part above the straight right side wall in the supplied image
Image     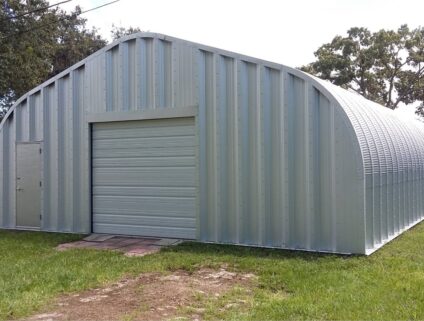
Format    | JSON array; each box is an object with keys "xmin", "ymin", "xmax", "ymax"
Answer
[{"xmin": 318, "ymin": 79, "xmax": 424, "ymax": 174}]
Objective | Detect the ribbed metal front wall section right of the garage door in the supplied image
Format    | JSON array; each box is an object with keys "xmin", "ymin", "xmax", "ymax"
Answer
[{"xmin": 199, "ymin": 55, "xmax": 364, "ymax": 252}]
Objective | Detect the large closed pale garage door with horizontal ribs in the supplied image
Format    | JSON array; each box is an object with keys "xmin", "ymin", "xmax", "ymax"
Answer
[{"xmin": 92, "ymin": 118, "xmax": 196, "ymax": 239}]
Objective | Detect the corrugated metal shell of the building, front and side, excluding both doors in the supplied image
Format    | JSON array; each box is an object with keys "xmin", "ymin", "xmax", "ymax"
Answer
[{"xmin": 0, "ymin": 33, "xmax": 424, "ymax": 253}]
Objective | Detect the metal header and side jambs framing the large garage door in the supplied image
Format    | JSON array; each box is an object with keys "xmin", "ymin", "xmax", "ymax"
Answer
[{"xmin": 87, "ymin": 106, "xmax": 200, "ymax": 239}]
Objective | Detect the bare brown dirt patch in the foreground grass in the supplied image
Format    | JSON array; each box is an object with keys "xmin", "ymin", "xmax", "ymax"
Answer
[{"xmin": 27, "ymin": 268, "xmax": 256, "ymax": 321}]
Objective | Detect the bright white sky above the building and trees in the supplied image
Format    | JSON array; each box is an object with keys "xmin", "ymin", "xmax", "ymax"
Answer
[{"xmin": 60, "ymin": 0, "xmax": 424, "ymax": 117}]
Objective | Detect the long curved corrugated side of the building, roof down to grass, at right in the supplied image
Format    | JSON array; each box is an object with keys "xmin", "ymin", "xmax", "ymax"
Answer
[{"xmin": 318, "ymin": 84, "xmax": 424, "ymax": 252}]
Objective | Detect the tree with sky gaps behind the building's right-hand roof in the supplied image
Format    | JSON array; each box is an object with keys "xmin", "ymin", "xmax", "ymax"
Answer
[{"xmin": 301, "ymin": 25, "xmax": 424, "ymax": 115}]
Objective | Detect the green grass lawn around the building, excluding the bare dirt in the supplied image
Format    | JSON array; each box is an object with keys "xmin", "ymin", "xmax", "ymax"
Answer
[{"xmin": 0, "ymin": 224, "xmax": 424, "ymax": 320}]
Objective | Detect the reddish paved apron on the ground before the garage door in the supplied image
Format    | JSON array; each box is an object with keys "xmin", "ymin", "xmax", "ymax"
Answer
[{"xmin": 57, "ymin": 236, "xmax": 180, "ymax": 256}]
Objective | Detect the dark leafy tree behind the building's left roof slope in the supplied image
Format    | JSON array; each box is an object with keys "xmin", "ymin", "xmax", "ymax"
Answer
[{"xmin": 0, "ymin": 0, "xmax": 106, "ymax": 119}]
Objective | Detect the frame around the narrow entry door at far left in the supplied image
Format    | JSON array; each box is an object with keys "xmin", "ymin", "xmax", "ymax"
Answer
[{"xmin": 13, "ymin": 140, "xmax": 44, "ymax": 231}]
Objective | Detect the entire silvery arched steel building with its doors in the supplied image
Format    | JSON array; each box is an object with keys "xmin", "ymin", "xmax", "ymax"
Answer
[{"xmin": 0, "ymin": 33, "xmax": 424, "ymax": 254}]
